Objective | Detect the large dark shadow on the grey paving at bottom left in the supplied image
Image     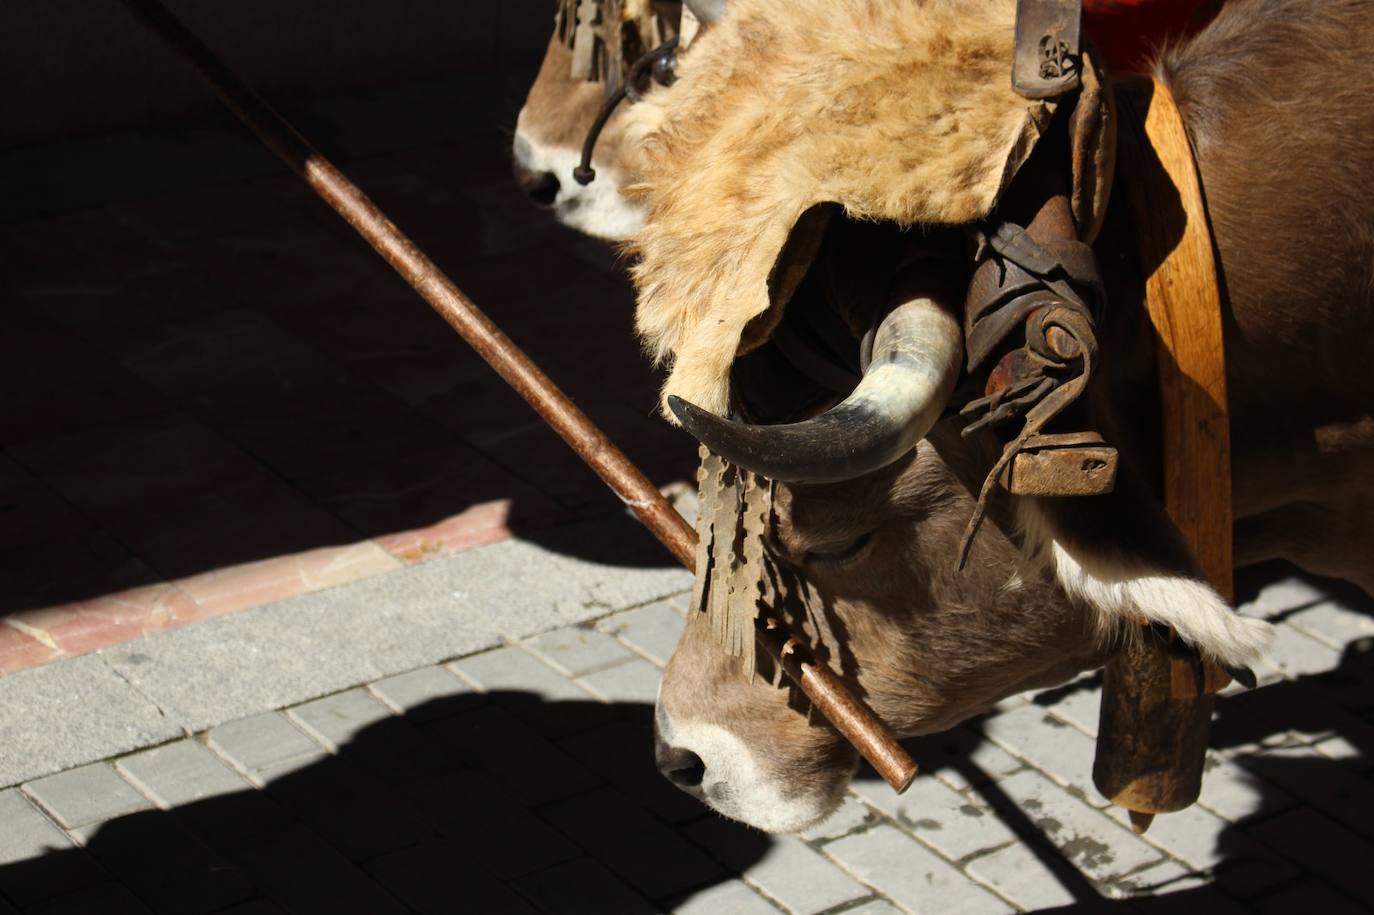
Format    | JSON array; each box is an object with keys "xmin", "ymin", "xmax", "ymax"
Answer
[{"xmin": 0, "ymin": 692, "xmax": 771, "ymax": 915}]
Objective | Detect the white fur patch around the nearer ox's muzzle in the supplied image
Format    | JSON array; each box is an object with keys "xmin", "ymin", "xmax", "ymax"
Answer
[{"xmin": 655, "ymin": 705, "xmax": 844, "ymax": 833}]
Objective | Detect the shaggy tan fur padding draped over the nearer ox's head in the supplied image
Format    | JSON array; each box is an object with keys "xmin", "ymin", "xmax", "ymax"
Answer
[{"xmin": 628, "ymin": 0, "xmax": 1052, "ymax": 419}]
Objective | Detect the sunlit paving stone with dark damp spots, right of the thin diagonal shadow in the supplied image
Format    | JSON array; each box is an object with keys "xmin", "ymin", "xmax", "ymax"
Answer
[{"xmin": 998, "ymin": 769, "xmax": 1160, "ymax": 881}]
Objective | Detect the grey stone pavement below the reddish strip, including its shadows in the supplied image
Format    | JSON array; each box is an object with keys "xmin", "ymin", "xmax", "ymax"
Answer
[{"xmin": 0, "ymin": 519, "xmax": 1374, "ymax": 915}]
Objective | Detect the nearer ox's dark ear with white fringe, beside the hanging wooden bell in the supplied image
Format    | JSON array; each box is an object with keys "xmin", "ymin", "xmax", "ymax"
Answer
[{"xmin": 1018, "ymin": 464, "xmax": 1272, "ymax": 668}]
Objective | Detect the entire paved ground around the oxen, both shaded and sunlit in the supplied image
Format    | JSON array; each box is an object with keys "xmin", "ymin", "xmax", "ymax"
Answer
[{"xmin": 0, "ymin": 33, "xmax": 1374, "ymax": 915}]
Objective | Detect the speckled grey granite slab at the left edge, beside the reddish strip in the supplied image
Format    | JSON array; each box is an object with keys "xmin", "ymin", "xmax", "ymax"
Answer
[{"xmin": 0, "ymin": 654, "xmax": 183, "ymax": 787}]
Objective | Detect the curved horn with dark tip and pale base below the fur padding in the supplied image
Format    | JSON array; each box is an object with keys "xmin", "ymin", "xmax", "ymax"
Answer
[{"xmin": 668, "ymin": 297, "xmax": 963, "ymax": 482}]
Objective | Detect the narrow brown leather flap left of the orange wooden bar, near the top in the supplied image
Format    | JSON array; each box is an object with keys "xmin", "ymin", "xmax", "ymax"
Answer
[{"xmin": 1069, "ymin": 43, "xmax": 1117, "ymax": 245}]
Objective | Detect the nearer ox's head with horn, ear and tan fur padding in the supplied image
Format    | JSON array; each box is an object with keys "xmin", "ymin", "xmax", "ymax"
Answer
[{"xmin": 627, "ymin": 0, "xmax": 1267, "ymax": 831}]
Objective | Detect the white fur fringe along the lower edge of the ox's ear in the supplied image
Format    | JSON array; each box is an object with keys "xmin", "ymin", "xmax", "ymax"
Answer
[{"xmin": 1050, "ymin": 540, "xmax": 1274, "ymax": 666}]
